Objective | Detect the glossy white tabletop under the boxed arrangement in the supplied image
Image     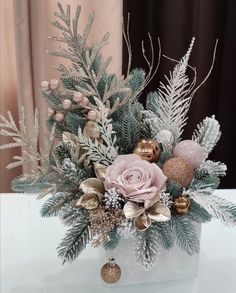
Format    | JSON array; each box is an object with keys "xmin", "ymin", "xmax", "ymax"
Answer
[{"xmin": 0, "ymin": 190, "xmax": 236, "ymax": 293}]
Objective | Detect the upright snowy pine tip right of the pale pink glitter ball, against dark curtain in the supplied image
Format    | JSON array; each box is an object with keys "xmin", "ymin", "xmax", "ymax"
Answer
[{"xmin": 192, "ymin": 115, "xmax": 221, "ymax": 158}]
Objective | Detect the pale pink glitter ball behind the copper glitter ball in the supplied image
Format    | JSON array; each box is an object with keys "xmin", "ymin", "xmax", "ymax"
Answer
[{"xmin": 173, "ymin": 140, "xmax": 205, "ymax": 169}]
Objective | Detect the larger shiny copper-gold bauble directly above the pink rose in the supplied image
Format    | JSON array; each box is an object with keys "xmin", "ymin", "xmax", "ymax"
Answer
[{"xmin": 134, "ymin": 139, "xmax": 161, "ymax": 163}]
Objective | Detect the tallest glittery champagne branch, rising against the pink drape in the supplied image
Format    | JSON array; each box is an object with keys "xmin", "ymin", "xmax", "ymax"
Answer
[{"xmin": 48, "ymin": 3, "xmax": 139, "ymax": 116}]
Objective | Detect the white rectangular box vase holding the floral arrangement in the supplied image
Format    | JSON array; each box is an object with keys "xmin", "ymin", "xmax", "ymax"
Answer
[{"xmin": 100, "ymin": 225, "xmax": 201, "ymax": 286}]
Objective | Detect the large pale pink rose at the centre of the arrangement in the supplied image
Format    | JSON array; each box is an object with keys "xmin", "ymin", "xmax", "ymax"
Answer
[{"xmin": 104, "ymin": 154, "xmax": 167, "ymax": 202}]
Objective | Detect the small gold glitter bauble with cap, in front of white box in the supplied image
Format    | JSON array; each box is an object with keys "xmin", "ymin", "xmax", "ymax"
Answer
[{"xmin": 101, "ymin": 257, "xmax": 121, "ymax": 284}]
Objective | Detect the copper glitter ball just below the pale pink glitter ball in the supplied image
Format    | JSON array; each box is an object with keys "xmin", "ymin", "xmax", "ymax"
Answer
[{"xmin": 162, "ymin": 158, "xmax": 193, "ymax": 187}]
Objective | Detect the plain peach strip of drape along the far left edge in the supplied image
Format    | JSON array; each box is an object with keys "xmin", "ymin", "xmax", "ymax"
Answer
[{"xmin": 0, "ymin": 0, "xmax": 22, "ymax": 192}]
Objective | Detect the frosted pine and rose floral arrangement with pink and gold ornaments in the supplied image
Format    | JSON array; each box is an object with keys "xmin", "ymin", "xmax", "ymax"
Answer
[{"xmin": 1, "ymin": 4, "xmax": 236, "ymax": 282}]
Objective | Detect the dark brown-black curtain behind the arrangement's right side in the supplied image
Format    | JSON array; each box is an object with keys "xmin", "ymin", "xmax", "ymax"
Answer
[{"xmin": 123, "ymin": 0, "xmax": 236, "ymax": 188}]
